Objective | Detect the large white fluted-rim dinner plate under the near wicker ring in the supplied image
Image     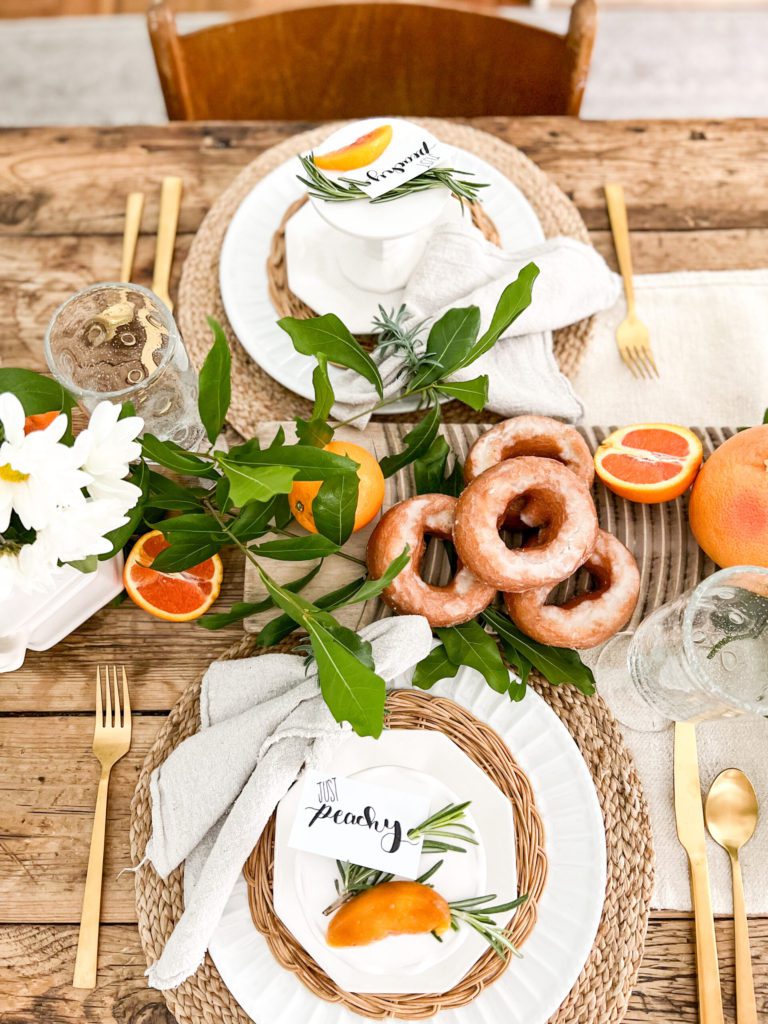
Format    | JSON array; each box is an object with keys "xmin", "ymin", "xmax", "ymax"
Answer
[{"xmin": 210, "ymin": 669, "xmax": 606, "ymax": 1024}]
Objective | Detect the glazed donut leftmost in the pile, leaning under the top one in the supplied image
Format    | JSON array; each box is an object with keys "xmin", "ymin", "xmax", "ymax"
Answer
[{"xmin": 367, "ymin": 495, "xmax": 496, "ymax": 628}]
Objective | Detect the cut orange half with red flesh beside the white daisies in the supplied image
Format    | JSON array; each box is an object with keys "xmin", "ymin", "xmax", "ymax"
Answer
[{"xmin": 123, "ymin": 529, "xmax": 224, "ymax": 623}]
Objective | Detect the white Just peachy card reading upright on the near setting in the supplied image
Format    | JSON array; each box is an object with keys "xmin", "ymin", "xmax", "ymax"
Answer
[{"xmin": 288, "ymin": 770, "xmax": 429, "ymax": 879}]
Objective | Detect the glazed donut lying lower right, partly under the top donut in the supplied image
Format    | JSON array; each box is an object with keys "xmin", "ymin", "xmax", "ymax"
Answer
[{"xmin": 504, "ymin": 529, "xmax": 640, "ymax": 649}]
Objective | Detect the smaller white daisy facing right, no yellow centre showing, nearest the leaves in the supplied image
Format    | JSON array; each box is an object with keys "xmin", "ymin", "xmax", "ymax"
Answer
[{"xmin": 75, "ymin": 401, "xmax": 144, "ymax": 509}]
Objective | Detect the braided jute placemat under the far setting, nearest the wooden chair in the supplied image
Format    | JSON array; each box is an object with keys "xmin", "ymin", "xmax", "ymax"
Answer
[{"xmin": 178, "ymin": 118, "xmax": 594, "ymax": 436}]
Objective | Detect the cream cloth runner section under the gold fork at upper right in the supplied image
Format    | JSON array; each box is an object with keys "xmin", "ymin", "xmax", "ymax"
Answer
[{"xmin": 573, "ymin": 269, "xmax": 768, "ymax": 427}]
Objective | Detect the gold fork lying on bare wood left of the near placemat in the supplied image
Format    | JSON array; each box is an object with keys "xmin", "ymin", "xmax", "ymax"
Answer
[{"xmin": 73, "ymin": 666, "xmax": 131, "ymax": 988}]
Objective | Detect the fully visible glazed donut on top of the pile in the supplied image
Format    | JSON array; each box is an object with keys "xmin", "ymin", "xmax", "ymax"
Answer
[{"xmin": 454, "ymin": 456, "xmax": 597, "ymax": 592}]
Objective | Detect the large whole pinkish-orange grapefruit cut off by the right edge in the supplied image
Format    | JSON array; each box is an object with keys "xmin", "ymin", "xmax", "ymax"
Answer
[{"xmin": 689, "ymin": 424, "xmax": 768, "ymax": 568}]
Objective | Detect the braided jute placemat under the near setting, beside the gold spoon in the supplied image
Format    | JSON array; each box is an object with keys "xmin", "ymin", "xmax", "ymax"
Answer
[{"xmin": 130, "ymin": 636, "xmax": 653, "ymax": 1024}]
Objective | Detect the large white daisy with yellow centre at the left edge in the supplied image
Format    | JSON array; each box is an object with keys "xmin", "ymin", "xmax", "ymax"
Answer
[{"xmin": 0, "ymin": 392, "xmax": 91, "ymax": 532}]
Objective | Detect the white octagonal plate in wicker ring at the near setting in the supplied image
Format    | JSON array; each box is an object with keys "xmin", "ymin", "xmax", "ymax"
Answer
[{"xmin": 273, "ymin": 729, "xmax": 517, "ymax": 992}]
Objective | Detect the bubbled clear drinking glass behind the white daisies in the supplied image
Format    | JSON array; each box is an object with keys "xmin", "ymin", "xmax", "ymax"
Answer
[{"xmin": 45, "ymin": 283, "xmax": 204, "ymax": 450}]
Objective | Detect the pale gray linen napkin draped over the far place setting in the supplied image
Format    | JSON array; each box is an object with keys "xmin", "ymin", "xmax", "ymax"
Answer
[{"xmin": 333, "ymin": 217, "xmax": 621, "ymax": 428}]
